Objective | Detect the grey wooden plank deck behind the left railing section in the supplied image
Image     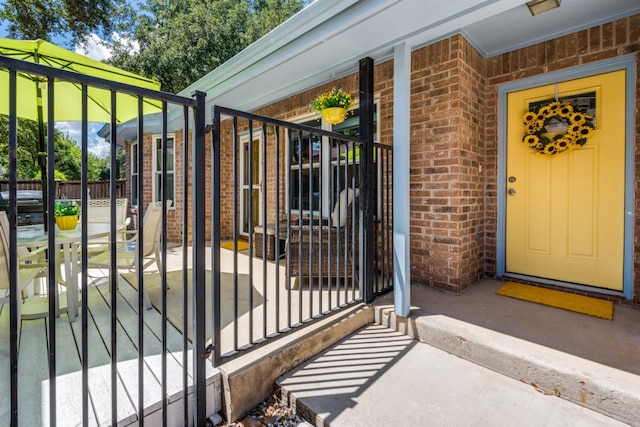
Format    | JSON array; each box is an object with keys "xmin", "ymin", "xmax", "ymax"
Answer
[{"xmin": 0, "ymin": 262, "xmax": 221, "ymax": 426}]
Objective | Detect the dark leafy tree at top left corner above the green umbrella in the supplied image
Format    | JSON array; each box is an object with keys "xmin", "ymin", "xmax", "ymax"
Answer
[{"xmin": 0, "ymin": 0, "xmax": 135, "ymax": 47}]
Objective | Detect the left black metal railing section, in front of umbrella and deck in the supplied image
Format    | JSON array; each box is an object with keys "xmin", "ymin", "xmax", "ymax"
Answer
[{"xmin": 0, "ymin": 55, "xmax": 210, "ymax": 426}]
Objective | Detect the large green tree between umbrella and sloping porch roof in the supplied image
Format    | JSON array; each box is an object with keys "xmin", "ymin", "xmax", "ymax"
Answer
[{"xmin": 109, "ymin": 0, "xmax": 304, "ymax": 93}]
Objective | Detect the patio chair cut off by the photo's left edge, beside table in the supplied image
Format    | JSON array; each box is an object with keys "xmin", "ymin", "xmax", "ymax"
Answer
[{"xmin": 0, "ymin": 211, "xmax": 44, "ymax": 348}]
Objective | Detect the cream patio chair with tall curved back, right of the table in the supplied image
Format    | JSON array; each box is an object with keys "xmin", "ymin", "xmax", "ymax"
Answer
[{"xmin": 87, "ymin": 200, "xmax": 172, "ymax": 309}]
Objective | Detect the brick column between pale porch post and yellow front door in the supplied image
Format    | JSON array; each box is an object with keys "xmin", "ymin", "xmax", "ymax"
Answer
[{"xmin": 410, "ymin": 35, "xmax": 485, "ymax": 292}]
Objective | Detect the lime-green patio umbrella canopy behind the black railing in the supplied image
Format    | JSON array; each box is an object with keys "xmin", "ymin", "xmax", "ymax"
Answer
[{"xmin": 0, "ymin": 38, "xmax": 160, "ymax": 123}]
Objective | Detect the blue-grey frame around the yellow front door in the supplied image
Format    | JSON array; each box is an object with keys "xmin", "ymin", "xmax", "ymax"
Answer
[{"xmin": 496, "ymin": 54, "xmax": 636, "ymax": 299}]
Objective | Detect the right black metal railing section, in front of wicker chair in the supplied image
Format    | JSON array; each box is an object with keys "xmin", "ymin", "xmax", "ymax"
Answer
[{"xmin": 207, "ymin": 106, "xmax": 393, "ymax": 364}]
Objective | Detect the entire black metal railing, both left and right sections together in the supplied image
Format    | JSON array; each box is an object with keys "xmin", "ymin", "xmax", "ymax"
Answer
[{"xmin": 0, "ymin": 51, "xmax": 393, "ymax": 426}]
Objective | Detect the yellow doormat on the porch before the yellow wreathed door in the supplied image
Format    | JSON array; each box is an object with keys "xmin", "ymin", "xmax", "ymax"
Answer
[{"xmin": 496, "ymin": 282, "xmax": 613, "ymax": 320}]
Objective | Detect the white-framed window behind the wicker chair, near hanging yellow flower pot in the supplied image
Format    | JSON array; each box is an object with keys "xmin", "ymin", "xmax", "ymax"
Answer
[{"xmin": 289, "ymin": 106, "xmax": 378, "ymax": 217}]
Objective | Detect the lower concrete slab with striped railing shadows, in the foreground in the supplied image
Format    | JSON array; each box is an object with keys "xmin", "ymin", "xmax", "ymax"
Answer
[{"xmin": 277, "ymin": 324, "xmax": 625, "ymax": 427}]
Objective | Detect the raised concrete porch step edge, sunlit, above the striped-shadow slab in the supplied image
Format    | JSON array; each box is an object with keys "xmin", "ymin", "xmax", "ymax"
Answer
[{"xmin": 376, "ymin": 306, "xmax": 640, "ymax": 426}]
